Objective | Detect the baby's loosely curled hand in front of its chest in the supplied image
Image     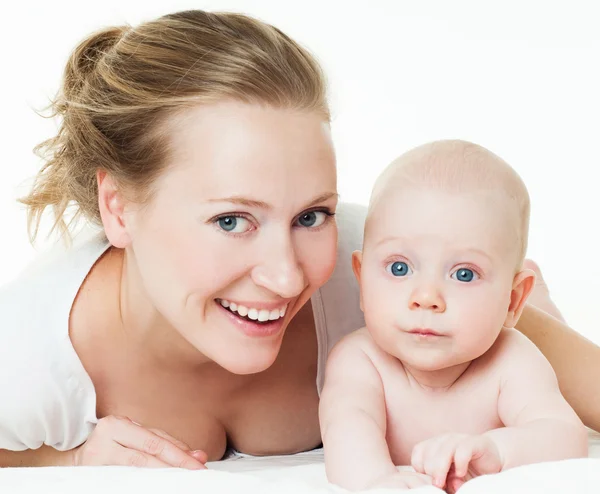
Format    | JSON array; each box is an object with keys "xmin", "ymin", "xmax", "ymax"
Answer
[{"xmin": 411, "ymin": 434, "xmax": 502, "ymax": 493}]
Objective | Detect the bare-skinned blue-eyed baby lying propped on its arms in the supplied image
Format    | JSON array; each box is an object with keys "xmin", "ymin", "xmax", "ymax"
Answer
[{"xmin": 319, "ymin": 141, "xmax": 587, "ymax": 492}]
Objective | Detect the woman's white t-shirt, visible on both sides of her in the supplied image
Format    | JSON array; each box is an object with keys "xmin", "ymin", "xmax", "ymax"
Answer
[{"xmin": 0, "ymin": 204, "xmax": 365, "ymax": 451}]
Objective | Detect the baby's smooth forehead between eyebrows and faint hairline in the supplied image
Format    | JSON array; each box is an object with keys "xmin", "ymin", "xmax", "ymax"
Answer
[{"xmin": 365, "ymin": 186, "xmax": 520, "ymax": 258}]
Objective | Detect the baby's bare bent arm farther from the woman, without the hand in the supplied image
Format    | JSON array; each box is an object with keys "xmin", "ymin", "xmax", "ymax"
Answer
[{"xmin": 486, "ymin": 330, "xmax": 587, "ymax": 469}]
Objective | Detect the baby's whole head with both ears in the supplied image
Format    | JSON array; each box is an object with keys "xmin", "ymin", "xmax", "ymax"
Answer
[{"xmin": 353, "ymin": 141, "xmax": 535, "ymax": 371}]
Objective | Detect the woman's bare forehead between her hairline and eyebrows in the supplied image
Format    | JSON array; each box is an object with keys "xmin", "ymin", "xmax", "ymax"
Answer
[{"xmin": 152, "ymin": 102, "xmax": 336, "ymax": 202}]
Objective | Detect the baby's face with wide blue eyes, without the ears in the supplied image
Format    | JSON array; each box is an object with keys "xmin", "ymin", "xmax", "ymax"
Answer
[{"xmin": 360, "ymin": 187, "xmax": 519, "ymax": 370}]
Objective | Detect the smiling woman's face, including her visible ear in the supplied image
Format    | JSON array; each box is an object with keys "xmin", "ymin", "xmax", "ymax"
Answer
[{"xmin": 125, "ymin": 101, "xmax": 337, "ymax": 374}]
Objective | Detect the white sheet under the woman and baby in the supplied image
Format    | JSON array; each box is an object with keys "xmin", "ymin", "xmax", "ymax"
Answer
[{"xmin": 0, "ymin": 432, "xmax": 600, "ymax": 494}]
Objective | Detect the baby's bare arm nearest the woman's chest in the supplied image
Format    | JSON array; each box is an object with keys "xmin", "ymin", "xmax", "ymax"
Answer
[{"xmin": 319, "ymin": 331, "xmax": 396, "ymax": 489}]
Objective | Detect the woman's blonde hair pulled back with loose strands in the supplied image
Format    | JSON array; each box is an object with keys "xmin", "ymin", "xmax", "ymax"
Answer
[{"xmin": 20, "ymin": 10, "xmax": 330, "ymax": 242}]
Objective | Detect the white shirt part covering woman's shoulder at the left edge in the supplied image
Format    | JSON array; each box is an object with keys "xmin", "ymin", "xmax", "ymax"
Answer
[{"xmin": 0, "ymin": 228, "xmax": 106, "ymax": 450}]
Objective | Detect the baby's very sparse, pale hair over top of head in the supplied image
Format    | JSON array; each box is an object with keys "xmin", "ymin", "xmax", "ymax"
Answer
[{"xmin": 367, "ymin": 140, "xmax": 530, "ymax": 269}]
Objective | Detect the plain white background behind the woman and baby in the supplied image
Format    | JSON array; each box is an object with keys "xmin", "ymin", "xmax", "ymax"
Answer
[{"xmin": 0, "ymin": 0, "xmax": 600, "ymax": 343}]
